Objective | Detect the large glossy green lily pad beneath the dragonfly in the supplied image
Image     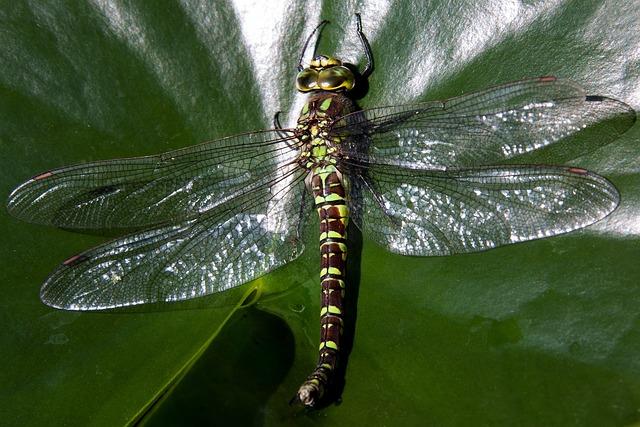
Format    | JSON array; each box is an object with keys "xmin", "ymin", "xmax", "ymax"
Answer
[{"xmin": 0, "ymin": 0, "xmax": 640, "ymax": 426}]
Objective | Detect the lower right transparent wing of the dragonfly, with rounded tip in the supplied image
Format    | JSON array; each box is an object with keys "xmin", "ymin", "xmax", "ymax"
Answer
[{"xmin": 352, "ymin": 165, "xmax": 619, "ymax": 256}]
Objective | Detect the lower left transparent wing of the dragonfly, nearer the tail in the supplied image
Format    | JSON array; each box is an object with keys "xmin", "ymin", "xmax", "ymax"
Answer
[{"xmin": 41, "ymin": 166, "xmax": 311, "ymax": 310}]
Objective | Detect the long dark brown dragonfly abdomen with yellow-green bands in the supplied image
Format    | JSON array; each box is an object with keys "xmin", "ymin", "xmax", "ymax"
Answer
[{"xmin": 297, "ymin": 165, "xmax": 349, "ymax": 406}]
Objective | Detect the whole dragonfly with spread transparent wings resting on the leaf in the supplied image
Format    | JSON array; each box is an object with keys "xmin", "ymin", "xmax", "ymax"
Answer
[{"xmin": 8, "ymin": 14, "xmax": 636, "ymax": 408}]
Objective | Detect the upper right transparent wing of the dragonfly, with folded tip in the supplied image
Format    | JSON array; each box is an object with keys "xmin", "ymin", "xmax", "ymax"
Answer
[{"xmin": 333, "ymin": 77, "xmax": 636, "ymax": 170}]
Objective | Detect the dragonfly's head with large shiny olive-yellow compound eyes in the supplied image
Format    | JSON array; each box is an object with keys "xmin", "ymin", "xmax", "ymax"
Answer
[{"xmin": 296, "ymin": 55, "xmax": 356, "ymax": 92}]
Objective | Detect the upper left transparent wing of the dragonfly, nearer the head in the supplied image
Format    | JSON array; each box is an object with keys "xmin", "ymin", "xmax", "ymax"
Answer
[{"xmin": 8, "ymin": 131, "xmax": 296, "ymax": 230}]
